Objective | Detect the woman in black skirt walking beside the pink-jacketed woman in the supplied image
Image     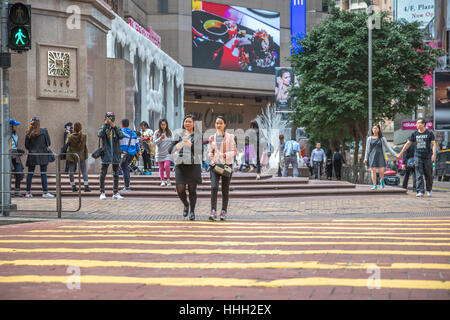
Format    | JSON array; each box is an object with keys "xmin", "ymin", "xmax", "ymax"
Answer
[{"xmin": 169, "ymin": 114, "xmax": 203, "ymax": 220}]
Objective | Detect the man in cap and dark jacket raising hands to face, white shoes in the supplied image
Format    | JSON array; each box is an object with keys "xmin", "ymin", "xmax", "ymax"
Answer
[{"xmin": 98, "ymin": 112, "xmax": 123, "ymax": 200}]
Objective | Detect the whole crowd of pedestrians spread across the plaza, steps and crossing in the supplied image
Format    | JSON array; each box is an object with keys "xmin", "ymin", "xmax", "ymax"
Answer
[{"xmin": 9, "ymin": 112, "xmax": 436, "ymax": 220}]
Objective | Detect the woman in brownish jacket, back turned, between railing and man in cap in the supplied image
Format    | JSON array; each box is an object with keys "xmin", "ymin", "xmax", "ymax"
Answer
[{"xmin": 66, "ymin": 122, "xmax": 91, "ymax": 192}]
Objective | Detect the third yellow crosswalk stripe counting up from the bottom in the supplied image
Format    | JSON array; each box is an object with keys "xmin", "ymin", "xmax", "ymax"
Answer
[{"xmin": 0, "ymin": 248, "xmax": 450, "ymax": 256}]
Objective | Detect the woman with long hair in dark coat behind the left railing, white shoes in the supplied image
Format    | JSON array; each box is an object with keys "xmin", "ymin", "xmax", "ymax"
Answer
[{"xmin": 25, "ymin": 117, "xmax": 55, "ymax": 198}]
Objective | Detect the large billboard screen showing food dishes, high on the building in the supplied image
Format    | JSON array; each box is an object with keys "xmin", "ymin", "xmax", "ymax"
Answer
[{"xmin": 192, "ymin": 0, "xmax": 280, "ymax": 74}]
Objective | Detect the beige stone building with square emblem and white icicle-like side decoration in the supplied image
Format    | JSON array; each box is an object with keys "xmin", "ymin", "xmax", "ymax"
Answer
[{"xmin": 5, "ymin": 0, "xmax": 184, "ymax": 172}]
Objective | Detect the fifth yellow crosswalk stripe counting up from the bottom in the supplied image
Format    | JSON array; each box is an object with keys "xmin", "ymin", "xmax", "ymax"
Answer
[{"xmin": 26, "ymin": 229, "xmax": 450, "ymax": 236}]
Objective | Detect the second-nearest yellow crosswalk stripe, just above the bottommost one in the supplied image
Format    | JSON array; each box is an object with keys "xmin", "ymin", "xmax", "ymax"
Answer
[{"xmin": 0, "ymin": 259, "xmax": 450, "ymax": 270}]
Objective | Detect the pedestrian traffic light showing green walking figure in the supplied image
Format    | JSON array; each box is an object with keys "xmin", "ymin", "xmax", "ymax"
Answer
[{"xmin": 8, "ymin": 2, "xmax": 31, "ymax": 51}]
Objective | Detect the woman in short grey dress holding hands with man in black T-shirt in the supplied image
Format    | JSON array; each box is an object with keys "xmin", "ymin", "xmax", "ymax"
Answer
[{"xmin": 364, "ymin": 124, "xmax": 397, "ymax": 190}]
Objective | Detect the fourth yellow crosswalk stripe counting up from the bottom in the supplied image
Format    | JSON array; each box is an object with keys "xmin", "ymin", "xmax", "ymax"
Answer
[{"xmin": 0, "ymin": 239, "xmax": 450, "ymax": 247}]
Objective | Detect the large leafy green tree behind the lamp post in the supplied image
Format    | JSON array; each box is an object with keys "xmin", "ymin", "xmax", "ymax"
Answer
[{"xmin": 290, "ymin": 8, "xmax": 443, "ymax": 175}]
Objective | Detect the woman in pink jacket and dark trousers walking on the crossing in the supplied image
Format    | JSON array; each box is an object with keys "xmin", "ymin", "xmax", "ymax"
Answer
[{"xmin": 208, "ymin": 116, "xmax": 237, "ymax": 221}]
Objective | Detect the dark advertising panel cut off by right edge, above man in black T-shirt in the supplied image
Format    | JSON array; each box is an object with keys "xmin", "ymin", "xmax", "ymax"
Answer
[{"xmin": 434, "ymin": 72, "xmax": 450, "ymax": 131}]
